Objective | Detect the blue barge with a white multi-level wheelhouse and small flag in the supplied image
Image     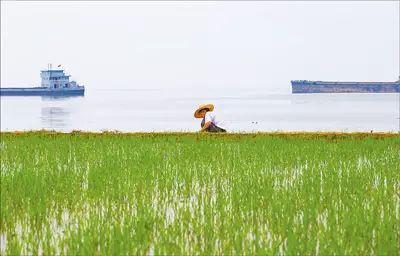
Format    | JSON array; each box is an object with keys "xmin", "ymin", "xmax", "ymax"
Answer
[{"xmin": 0, "ymin": 66, "xmax": 85, "ymax": 96}]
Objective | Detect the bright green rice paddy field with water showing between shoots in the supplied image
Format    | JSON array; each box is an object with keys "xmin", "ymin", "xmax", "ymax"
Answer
[{"xmin": 0, "ymin": 132, "xmax": 400, "ymax": 255}]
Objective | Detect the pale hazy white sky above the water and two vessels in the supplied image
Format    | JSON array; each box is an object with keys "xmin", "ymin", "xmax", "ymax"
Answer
[{"xmin": 1, "ymin": 1, "xmax": 400, "ymax": 89}]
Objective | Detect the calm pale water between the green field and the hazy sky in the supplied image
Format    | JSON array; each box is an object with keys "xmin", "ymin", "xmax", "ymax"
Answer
[{"xmin": 1, "ymin": 89, "xmax": 400, "ymax": 132}]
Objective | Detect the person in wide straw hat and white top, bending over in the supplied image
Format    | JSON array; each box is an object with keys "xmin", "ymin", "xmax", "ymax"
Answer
[{"xmin": 194, "ymin": 104, "xmax": 226, "ymax": 132}]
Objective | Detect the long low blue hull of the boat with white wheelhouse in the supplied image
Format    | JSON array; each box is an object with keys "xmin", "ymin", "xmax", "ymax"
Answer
[{"xmin": 0, "ymin": 86, "xmax": 85, "ymax": 96}]
